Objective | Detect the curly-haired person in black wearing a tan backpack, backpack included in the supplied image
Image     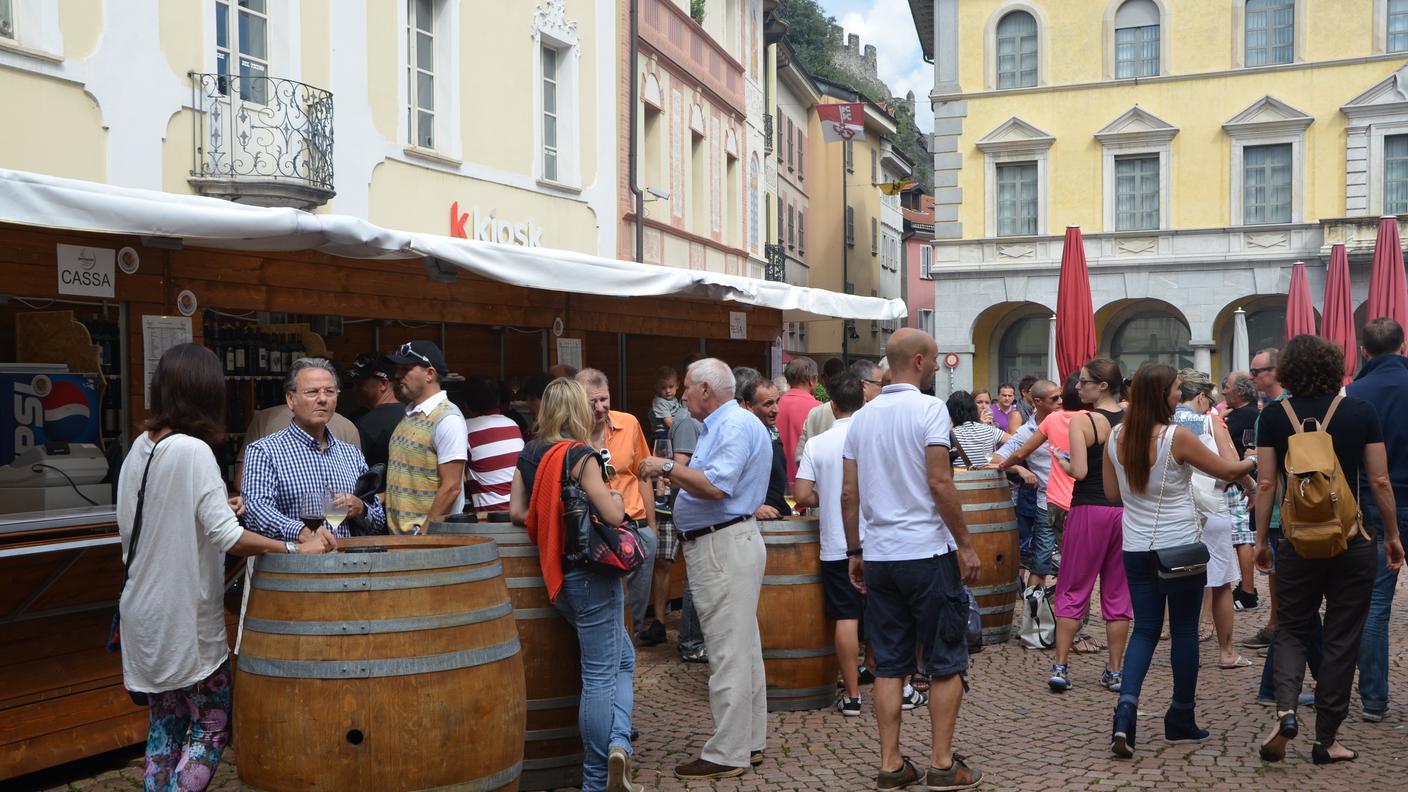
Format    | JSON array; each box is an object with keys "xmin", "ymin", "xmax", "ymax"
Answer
[{"xmin": 1256, "ymin": 335, "xmax": 1404, "ymax": 764}]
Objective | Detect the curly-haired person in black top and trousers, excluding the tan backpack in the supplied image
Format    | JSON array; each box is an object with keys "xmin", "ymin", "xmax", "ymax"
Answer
[{"xmin": 1256, "ymin": 335, "xmax": 1404, "ymax": 764}]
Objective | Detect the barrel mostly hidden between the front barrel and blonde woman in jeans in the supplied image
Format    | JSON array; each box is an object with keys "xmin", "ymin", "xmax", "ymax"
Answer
[{"xmin": 429, "ymin": 521, "xmax": 583, "ymax": 791}]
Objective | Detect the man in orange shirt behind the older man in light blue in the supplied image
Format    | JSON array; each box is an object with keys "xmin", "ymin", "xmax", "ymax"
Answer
[{"xmin": 576, "ymin": 368, "xmax": 665, "ymax": 643}]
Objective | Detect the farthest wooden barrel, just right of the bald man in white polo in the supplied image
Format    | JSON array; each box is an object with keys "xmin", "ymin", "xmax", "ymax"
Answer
[{"xmin": 953, "ymin": 469, "xmax": 1021, "ymax": 645}]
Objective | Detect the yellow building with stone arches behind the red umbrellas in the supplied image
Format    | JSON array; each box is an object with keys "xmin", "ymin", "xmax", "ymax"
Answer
[{"xmin": 910, "ymin": 0, "xmax": 1408, "ymax": 388}]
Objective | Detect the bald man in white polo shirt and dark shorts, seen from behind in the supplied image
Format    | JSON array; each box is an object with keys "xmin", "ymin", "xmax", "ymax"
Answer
[{"xmin": 841, "ymin": 328, "xmax": 983, "ymax": 789}]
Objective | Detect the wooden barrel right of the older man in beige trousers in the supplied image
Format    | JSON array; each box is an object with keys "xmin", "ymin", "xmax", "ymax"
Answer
[{"xmin": 758, "ymin": 517, "xmax": 836, "ymax": 712}]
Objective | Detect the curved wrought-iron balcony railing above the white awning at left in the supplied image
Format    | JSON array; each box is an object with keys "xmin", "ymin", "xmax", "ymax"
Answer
[{"xmin": 190, "ymin": 72, "xmax": 334, "ymax": 192}]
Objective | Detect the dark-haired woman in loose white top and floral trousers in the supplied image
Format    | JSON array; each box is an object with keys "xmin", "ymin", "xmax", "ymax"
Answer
[{"xmin": 117, "ymin": 344, "xmax": 332, "ymax": 791}]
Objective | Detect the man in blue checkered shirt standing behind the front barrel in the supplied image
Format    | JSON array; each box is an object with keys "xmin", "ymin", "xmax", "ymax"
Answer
[{"xmin": 241, "ymin": 358, "xmax": 386, "ymax": 544}]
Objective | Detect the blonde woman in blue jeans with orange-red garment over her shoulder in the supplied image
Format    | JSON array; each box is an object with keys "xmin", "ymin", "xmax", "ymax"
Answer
[{"xmin": 508, "ymin": 378, "xmax": 641, "ymax": 792}]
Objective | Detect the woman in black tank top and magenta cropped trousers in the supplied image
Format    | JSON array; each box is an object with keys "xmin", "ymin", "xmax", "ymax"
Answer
[{"xmin": 1046, "ymin": 358, "xmax": 1133, "ymax": 693}]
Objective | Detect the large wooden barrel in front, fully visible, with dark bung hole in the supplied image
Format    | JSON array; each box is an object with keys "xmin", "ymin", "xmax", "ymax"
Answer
[{"xmin": 234, "ymin": 536, "xmax": 525, "ymax": 792}]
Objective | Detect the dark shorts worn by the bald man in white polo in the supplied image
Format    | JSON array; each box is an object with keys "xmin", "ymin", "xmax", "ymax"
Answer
[{"xmin": 866, "ymin": 552, "xmax": 969, "ymax": 678}]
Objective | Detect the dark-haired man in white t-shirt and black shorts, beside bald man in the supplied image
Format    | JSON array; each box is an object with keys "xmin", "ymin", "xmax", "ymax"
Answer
[{"xmin": 794, "ymin": 373, "xmax": 866, "ymax": 717}]
